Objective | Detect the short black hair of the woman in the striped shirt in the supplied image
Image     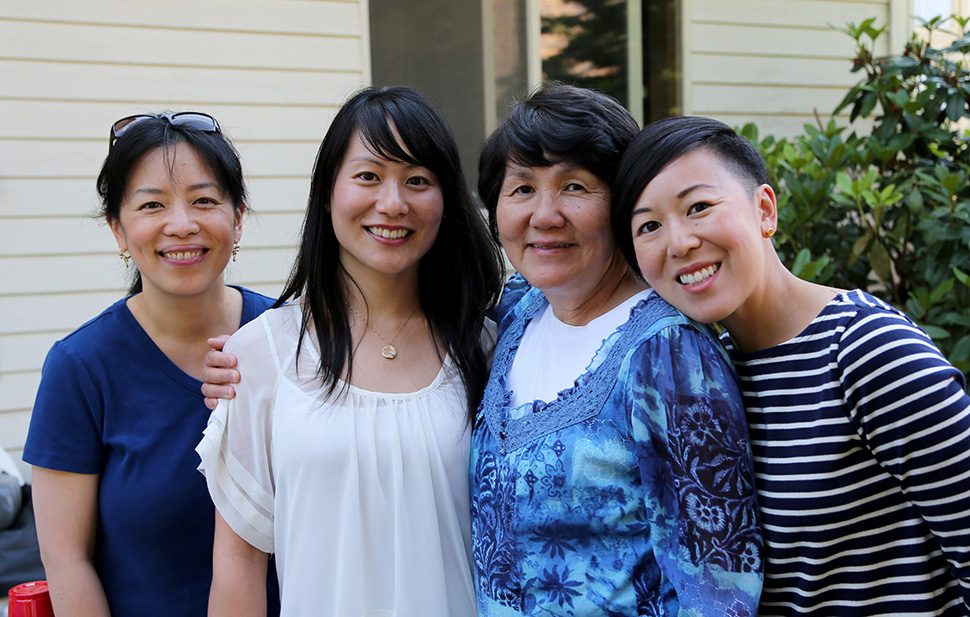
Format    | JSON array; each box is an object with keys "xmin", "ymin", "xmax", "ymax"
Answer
[{"xmin": 610, "ymin": 116, "xmax": 768, "ymax": 275}]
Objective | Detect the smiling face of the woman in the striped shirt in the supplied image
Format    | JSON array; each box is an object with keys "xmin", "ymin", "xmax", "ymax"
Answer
[{"xmin": 631, "ymin": 148, "xmax": 777, "ymax": 329}]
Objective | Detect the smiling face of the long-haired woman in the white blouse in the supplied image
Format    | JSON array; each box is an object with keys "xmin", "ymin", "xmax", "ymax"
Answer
[{"xmin": 330, "ymin": 134, "xmax": 444, "ymax": 280}]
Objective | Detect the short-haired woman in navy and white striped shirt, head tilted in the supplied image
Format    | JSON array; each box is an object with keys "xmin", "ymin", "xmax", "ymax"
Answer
[{"xmin": 613, "ymin": 117, "xmax": 970, "ymax": 616}]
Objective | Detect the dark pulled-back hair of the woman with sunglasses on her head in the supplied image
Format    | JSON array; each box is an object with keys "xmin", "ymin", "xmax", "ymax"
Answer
[{"xmin": 97, "ymin": 115, "xmax": 246, "ymax": 294}]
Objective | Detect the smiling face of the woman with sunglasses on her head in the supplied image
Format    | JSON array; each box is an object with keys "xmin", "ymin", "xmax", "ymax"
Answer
[{"xmin": 109, "ymin": 143, "xmax": 243, "ymax": 296}]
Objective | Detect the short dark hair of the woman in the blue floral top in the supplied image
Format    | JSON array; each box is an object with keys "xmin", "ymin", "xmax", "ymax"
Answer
[{"xmin": 478, "ymin": 83, "xmax": 639, "ymax": 239}]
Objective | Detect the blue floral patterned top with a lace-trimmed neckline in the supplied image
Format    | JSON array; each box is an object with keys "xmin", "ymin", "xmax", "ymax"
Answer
[{"xmin": 470, "ymin": 277, "xmax": 762, "ymax": 617}]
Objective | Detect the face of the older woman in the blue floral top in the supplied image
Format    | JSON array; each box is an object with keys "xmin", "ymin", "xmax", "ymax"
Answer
[{"xmin": 495, "ymin": 162, "xmax": 616, "ymax": 301}]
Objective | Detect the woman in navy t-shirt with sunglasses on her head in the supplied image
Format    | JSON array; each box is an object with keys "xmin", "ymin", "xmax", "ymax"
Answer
[{"xmin": 24, "ymin": 112, "xmax": 272, "ymax": 617}]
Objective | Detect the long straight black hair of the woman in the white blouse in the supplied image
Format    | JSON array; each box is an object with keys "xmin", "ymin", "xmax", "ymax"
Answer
[{"xmin": 277, "ymin": 86, "xmax": 502, "ymax": 419}]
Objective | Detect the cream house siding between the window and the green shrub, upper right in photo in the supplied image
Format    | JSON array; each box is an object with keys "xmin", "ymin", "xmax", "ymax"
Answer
[{"xmin": 683, "ymin": 0, "xmax": 911, "ymax": 135}]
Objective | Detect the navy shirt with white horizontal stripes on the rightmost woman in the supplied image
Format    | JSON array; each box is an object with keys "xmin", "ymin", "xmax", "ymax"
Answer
[{"xmin": 724, "ymin": 291, "xmax": 970, "ymax": 617}]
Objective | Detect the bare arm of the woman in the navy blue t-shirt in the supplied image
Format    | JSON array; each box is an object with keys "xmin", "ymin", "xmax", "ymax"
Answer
[{"xmin": 33, "ymin": 467, "xmax": 110, "ymax": 617}]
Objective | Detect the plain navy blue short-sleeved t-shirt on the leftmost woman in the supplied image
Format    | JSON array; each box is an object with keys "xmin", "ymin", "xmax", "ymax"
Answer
[{"xmin": 23, "ymin": 289, "xmax": 275, "ymax": 617}]
